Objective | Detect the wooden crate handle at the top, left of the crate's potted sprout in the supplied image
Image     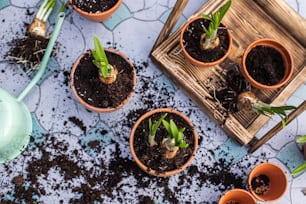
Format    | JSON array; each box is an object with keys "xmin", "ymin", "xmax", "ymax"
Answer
[{"xmin": 151, "ymin": 0, "xmax": 189, "ymax": 53}]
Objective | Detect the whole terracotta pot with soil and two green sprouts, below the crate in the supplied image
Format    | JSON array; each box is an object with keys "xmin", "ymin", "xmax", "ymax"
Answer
[{"xmin": 129, "ymin": 108, "xmax": 198, "ymax": 177}]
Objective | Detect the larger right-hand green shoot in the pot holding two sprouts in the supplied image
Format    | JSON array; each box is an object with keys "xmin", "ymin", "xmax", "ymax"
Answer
[{"xmin": 162, "ymin": 119, "xmax": 188, "ymax": 151}]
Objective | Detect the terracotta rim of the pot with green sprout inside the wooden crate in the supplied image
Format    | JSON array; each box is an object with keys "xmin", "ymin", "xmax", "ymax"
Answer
[{"xmin": 180, "ymin": 16, "xmax": 232, "ymax": 67}]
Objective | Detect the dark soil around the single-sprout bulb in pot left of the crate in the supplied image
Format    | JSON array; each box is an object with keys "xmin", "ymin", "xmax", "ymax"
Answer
[{"xmin": 74, "ymin": 51, "xmax": 134, "ymax": 108}]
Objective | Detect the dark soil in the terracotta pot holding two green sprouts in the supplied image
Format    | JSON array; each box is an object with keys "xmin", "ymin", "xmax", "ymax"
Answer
[{"xmin": 134, "ymin": 113, "xmax": 194, "ymax": 174}]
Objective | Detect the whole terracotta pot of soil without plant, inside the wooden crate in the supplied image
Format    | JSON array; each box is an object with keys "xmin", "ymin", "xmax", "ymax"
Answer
[{"xmin": 241, "ymin": 38, "xmax": 293, "ymax": 89}]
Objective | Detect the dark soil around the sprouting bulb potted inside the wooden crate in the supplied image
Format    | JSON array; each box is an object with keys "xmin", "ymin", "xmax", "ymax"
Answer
[{"xmin": 183, "ymin": 19, "xmax": 229, "ymax": 62}]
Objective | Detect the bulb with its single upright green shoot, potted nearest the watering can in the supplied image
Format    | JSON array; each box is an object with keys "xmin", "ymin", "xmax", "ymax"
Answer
[{"xmin": 92, "ymin": 36, "xmax": 117, "ymax": 84}]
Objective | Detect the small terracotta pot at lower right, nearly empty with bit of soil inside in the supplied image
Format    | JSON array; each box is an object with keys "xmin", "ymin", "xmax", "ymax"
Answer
[{"xmin": 248, "ymin": 163, "xmax": 288, "ymax": 202}]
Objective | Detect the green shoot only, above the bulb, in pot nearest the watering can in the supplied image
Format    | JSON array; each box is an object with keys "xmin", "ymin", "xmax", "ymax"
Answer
[{"xmin": 92, "ymin": 36, "xmax": 113, "ymax": 78}]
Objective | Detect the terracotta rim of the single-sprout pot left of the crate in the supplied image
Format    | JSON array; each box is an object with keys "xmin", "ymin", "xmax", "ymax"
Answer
[{"xmin": 70, "ymin": 48, "xmax": 136, "ymax": 112}]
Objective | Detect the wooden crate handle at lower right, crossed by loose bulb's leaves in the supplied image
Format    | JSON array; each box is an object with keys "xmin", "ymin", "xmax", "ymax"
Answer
[{"xmin": 248, "ymin": 100, "xmax": 306, "ymax": 153}]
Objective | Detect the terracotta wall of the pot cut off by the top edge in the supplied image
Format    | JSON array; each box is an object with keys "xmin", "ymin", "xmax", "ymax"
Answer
[{"xmin": 69, "ymin": 0, "xmax": 122, "ymax": 22}]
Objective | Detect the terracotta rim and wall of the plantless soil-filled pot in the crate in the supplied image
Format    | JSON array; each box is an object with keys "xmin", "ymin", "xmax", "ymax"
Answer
[{"xmin": 241, "ymin": 38, "xmax": 294, "ymax": 90}]
